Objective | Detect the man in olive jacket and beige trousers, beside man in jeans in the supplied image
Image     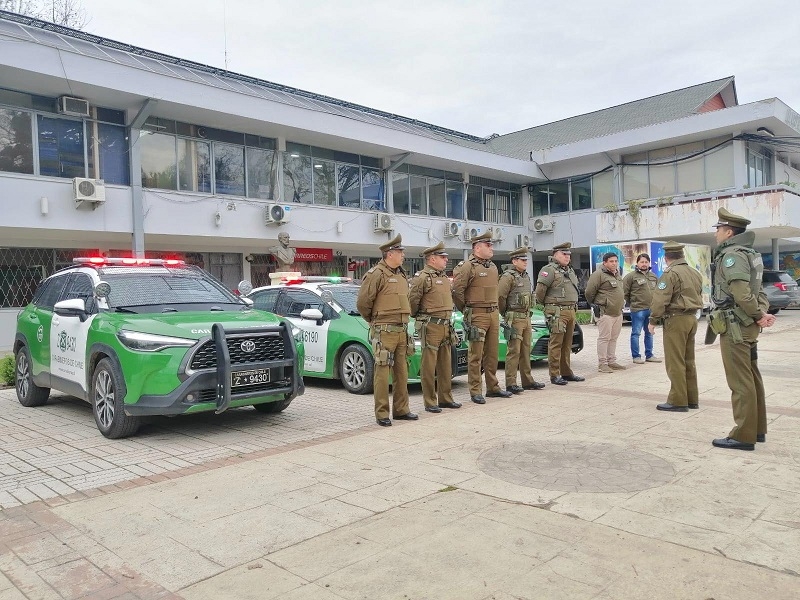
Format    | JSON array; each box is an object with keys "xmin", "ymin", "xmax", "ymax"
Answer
[{"xmin": 584, "ymin": 252, "xmax": 627, "ymax": 373}]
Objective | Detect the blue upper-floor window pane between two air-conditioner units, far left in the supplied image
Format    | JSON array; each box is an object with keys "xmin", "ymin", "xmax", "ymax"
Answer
[{"xmin": 39, "ymin": 115, "xmax": 86, "ymax": 178}]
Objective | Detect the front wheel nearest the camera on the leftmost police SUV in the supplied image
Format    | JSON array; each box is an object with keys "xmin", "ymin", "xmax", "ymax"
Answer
[{"xmin": 89, "ymin": 358, "xmax": 141, "ymax": 440}]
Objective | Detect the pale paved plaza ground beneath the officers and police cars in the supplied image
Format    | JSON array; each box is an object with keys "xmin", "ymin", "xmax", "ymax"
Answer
[{"xmin": 0, "ymin": 311, "xmax": 800, "ymax": 600}]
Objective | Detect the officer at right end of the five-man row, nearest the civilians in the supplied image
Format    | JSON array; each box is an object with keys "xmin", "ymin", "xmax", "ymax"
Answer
[{"xmin": 536, "ymin": 242, "xmax": 584, "ymax": 385}]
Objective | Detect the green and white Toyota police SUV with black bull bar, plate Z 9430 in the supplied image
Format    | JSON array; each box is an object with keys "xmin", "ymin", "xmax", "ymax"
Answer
[{"xmin": 14, "ymin": 258, "xmax": 304, "ymax": 438}]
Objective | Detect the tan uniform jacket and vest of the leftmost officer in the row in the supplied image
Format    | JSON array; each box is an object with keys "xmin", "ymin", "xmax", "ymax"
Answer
[{"xmin": 356, "ymin": 260, "xmax": 411, "ymax": 325}]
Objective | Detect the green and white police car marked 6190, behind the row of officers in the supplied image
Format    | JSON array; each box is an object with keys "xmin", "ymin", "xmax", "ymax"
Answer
[{"xmin": 248, "ymin": 272, "xmax": 467, "ymax": 394}]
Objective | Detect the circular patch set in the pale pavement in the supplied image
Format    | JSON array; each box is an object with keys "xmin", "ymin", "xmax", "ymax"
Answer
[{"xmin": 478, "ymin": 440, "xmax": 675, "ymax": 493}]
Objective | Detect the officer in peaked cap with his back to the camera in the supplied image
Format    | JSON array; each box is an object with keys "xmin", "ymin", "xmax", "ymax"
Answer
[{"xmin": 647, "ymin": 242, "xmax": 703, "ymax": 412}]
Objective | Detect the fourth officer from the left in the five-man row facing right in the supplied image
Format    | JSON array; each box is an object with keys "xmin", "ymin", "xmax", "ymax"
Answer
[{"xmin": 497, "ymin": 246, "xmax": 544, "ymax": 394}]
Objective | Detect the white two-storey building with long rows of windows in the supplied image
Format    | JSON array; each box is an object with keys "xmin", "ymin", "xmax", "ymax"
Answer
[{"xmin": 0, "ymin": 12, "xmax": 800, "ymax": 351}]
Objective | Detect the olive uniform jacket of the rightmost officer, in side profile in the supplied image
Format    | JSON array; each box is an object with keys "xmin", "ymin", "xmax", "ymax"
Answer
[{"xmin": 712, "ymin": 231, "xmax": 769, "ymax": 321}]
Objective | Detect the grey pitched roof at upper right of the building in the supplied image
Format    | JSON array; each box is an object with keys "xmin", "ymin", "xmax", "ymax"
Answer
[{"xmin": 487, "ymin": 76, "xmax": 735, "ymax": 159}]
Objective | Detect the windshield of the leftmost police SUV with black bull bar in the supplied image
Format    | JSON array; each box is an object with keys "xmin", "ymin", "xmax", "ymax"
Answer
[{"xmin": 100, "ymin": 267, "xmax": 242, "ymax": 310}]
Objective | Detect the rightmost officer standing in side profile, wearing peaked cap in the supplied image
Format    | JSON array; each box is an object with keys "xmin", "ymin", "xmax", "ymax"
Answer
[{"xmin": 706, "ymin": 208, "xmax": 775, "ymax": 450}]
